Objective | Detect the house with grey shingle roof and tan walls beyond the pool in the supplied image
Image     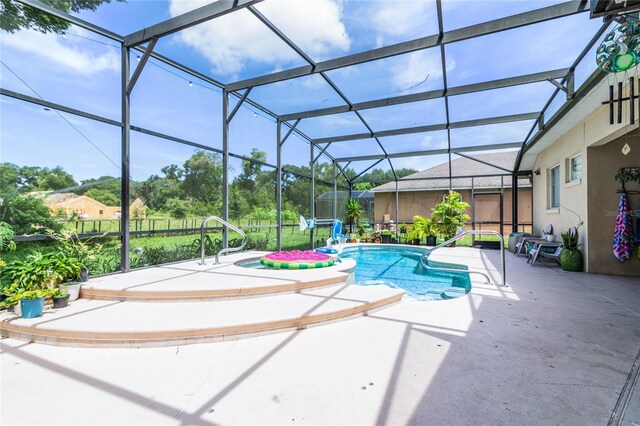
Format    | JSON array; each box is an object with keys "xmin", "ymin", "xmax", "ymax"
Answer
[{"xmin": 372, "ymin": 151, "xmax": 531, "ymax": 233}]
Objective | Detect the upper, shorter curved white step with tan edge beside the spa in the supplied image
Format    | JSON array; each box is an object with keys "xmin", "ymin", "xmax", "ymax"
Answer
[{"xmin": 81, "ymin": 252, "xmax": 355, "ymax": 302}]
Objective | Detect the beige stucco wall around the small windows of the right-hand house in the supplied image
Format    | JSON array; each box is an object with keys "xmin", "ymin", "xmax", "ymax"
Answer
[{"xmin": 533, "ymin": 78, "xmax": 640, "ymax": 274}]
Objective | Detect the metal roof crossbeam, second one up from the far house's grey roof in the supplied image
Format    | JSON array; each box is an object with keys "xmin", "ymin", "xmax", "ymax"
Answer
[{"xmin": 313, "ymin": 112, "xmax": 540, "ymax": 145}]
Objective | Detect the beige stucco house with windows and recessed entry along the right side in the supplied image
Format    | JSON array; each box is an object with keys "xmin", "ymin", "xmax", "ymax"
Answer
[{"xmin": 519, "ymin": 68, "xmax": 640, "ymax": 276}]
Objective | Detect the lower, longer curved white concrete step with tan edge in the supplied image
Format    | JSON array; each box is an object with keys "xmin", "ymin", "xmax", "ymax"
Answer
[{"xmin": 0, "ymin": 284, "xmax": 404, "ymax": 347}]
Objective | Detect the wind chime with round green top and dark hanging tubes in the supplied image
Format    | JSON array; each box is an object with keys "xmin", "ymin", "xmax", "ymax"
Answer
[{"xmin": 596, "ymin": 21, "xmax": 640, "ymax": 124}]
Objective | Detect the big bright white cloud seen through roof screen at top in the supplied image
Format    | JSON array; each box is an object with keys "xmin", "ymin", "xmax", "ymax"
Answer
[{"xmin": 169, "ymin": 0, "xmax": 350, "ymax": 77}]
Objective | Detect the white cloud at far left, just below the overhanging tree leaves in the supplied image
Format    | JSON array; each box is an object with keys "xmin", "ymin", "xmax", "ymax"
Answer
[{"xmin": 2, "ymin": 30, "xmax": 120, "ymax": 75}]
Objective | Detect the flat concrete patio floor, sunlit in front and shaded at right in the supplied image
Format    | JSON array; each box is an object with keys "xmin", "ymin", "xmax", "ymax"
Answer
[{"xmin": 0, "ymin": 248, "xmax": 640, "ymax": 425}]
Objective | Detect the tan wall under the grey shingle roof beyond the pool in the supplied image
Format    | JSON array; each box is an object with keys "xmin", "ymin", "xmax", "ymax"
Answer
[{"xmin": 374, "ymin": 188, "xmax": 531, "ymax": 233}]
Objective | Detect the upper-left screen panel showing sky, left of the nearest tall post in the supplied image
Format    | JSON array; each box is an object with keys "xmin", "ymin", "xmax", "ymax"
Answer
[{"xmin": 0, "ymin": 25, "xmax": 121, "ymax": 119}]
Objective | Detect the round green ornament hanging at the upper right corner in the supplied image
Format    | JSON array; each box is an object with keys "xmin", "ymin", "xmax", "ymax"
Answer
[{"xmin": 596, "ymin": 21, "xmax": 640, "ymax": 73}]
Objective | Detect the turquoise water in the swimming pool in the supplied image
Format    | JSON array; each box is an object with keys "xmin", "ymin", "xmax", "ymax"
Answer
[{"xmin": 341, "ymin": 246, "xmax": 471, "ymax": 300}]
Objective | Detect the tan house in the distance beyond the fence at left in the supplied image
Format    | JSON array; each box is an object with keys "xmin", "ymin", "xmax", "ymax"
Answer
[{"xmin": 44, "ymin": 192, "xmax": 147, "ymax": 219}]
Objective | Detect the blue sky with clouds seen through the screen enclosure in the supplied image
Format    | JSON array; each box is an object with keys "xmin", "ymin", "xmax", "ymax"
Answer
[{"xmin": 0, "ymin": 0, "xmax": 601, "ymax": 184}]
